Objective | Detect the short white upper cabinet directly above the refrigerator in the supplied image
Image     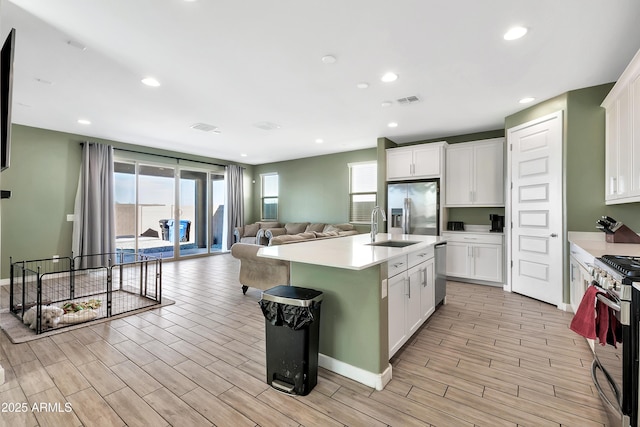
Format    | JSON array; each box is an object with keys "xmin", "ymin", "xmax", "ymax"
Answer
[{"xmin": 387, "ymin": 142, "xmax": 447, "ymax": 181}]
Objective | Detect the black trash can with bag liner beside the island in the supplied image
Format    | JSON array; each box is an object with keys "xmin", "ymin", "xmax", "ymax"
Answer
[{"xmin": 260, "ymin": 285, "xmax": 322, "ymax": 396}]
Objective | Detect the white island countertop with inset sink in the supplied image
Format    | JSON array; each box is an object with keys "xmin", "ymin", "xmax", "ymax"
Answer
[{"xmin": 258, "ymin": 233, "xmax": 446, "ymax": 270}]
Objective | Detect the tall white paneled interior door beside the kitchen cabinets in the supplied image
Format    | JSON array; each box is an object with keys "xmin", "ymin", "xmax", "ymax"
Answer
[{"xmin": 507, "ymin": 112, "xmax": 564, "ymax": 306}]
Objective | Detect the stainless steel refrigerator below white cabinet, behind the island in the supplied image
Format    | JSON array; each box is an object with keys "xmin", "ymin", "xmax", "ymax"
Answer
[{"xmin": 387, "ymin": 179, "xmax": 440, "ymax": 236}]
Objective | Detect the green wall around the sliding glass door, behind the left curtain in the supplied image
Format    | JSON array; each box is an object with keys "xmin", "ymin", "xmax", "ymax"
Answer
[{"xmin": 0, "ymin": 125, "xmax": 253, "ymax": 278}]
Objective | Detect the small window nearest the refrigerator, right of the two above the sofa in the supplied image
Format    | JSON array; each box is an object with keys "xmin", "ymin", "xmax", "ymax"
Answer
[{"xmin": 349, "ymin": 162, "xmax": 378, "ymax": 223}]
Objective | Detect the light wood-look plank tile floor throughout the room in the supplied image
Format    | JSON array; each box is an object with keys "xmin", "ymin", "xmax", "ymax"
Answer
[{"xmin": 0, "ymin": 254, "xmax": 607, "ymax": 427}]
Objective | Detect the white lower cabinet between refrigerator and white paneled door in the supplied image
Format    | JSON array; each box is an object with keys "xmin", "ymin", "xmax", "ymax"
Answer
[{"xmin": 442, "ymin": 232, "xmax": 504, "ymax": 283}]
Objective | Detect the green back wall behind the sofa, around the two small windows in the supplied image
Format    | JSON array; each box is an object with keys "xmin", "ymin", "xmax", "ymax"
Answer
[{"xmin": 251, "ymin": 148, "xmax": 377, "ymax": 231}]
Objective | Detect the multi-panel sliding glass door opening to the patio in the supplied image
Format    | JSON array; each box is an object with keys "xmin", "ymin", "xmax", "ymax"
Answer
[{"xmin": 115, "ymin": 161, "xmax": 226, "ymax": 259}]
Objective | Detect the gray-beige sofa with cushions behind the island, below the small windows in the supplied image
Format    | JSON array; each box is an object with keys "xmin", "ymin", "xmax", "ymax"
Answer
[{"xmin": 264, "ymin": 222, "xmax": 358, "ymax": 246}]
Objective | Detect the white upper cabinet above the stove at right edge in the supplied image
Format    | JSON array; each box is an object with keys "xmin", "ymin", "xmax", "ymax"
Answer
[{"xmin": 602, "ymin": 47, "xmax": 640, "ymax": 204}]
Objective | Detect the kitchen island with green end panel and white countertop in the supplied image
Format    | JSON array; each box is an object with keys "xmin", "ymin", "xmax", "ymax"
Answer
[{"xmin": 258, "ymin": 233, "xmax": 444, "ymax": 390}]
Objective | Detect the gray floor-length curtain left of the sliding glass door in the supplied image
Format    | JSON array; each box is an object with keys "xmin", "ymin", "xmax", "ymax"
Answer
[{"xmin": 73, "ymin": 142, "xmax": 116, "ymax": 268}]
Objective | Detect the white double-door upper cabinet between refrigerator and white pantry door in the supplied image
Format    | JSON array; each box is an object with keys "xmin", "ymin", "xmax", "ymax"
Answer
[{"xmin": 445, "ymin": 138, "xmax": 504, "ymax": 206}]
